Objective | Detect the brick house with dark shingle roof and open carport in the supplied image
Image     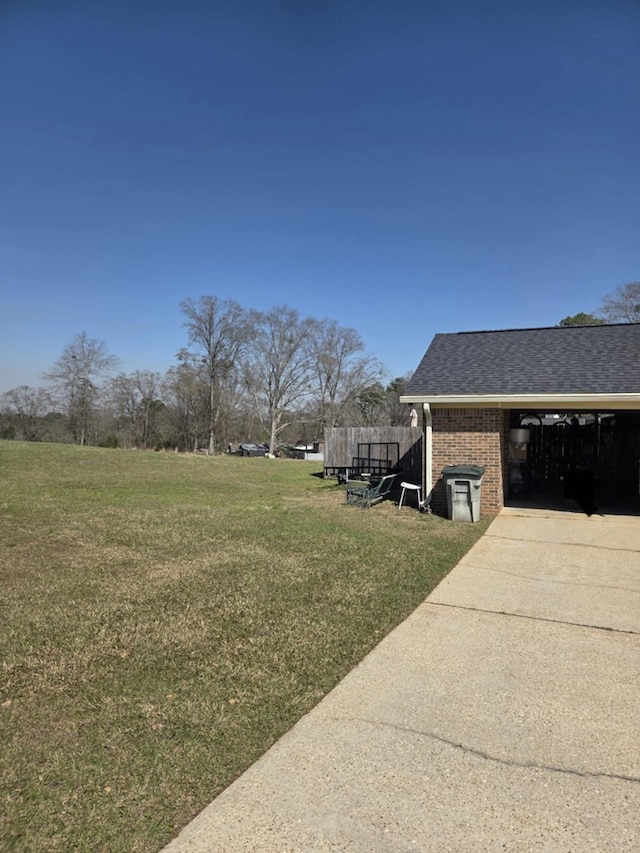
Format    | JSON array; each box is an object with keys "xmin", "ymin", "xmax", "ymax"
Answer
[{"xmin": 401, "ymin": 323, "xmax": 640, "ymax": 515}]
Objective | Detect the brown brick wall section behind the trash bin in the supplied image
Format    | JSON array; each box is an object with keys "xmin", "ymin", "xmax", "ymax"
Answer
[{"xmin": 431, "ymin": 409, "xmax": 509, "ymax": 515}]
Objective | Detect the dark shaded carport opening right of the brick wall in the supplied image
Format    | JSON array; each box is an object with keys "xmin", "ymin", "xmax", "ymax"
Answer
[{"xmin": 506, "ymin": 411, "xmax": 640, "ymax": 514}]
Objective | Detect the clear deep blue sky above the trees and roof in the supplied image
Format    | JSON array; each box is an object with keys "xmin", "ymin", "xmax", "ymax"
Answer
[{"xmin": 0, "ymin": 0, "xmax": 640, "ymax": 392}]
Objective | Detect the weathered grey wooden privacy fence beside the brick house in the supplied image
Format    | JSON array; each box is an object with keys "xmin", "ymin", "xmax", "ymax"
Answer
[{"xmin": 324, "ymin": 427, "xmax": 422, "ymax": 483}]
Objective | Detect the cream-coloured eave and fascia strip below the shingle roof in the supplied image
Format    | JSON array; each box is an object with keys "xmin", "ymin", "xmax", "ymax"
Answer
[{"xmin": 400, "ymin": 394, "xmax": 640, "ymax": 410}]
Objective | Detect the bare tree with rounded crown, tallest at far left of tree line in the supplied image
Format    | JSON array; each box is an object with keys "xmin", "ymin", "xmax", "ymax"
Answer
[{"xmin": 43, "ymin": 332, "xmax": 118, "ymax": 444}]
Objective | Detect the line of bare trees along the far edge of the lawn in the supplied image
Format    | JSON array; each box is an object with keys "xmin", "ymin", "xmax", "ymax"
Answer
[{"xmin": 0, "ymin": 296, "xmax": 408, "ymax": 454}]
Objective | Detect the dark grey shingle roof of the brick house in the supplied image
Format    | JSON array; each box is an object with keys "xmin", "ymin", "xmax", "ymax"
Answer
[{"xmin": 405, "ymin": 323, "xmax": 640, "ymax": 396}]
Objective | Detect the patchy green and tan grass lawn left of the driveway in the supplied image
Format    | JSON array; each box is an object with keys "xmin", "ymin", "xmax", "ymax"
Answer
[{"xmin": 0, "ymin": 442, "xmax": 487, "ymax": 853}]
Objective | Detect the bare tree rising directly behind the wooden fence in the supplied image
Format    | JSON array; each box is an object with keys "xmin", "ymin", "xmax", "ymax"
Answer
[{"xmin": 307, "ymin": 320, "xmax": 383, "ymax": 427}]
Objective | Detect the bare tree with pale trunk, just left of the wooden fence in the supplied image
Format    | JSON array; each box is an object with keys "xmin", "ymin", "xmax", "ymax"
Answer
[{"xmin": 243, "ymin": 306, "xmax": 314, "ymax": 454}]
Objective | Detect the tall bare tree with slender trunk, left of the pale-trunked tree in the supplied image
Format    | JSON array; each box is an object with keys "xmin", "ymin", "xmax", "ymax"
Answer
[{"xmin": 178, "ymin": 296, "xmax": 251, "ymax": 454}]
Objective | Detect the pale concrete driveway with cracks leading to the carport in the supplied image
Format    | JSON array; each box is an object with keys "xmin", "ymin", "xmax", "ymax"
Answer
[{"xmin": 165, "ymin": 510, "xmax": 640, "ymax": 853}]
